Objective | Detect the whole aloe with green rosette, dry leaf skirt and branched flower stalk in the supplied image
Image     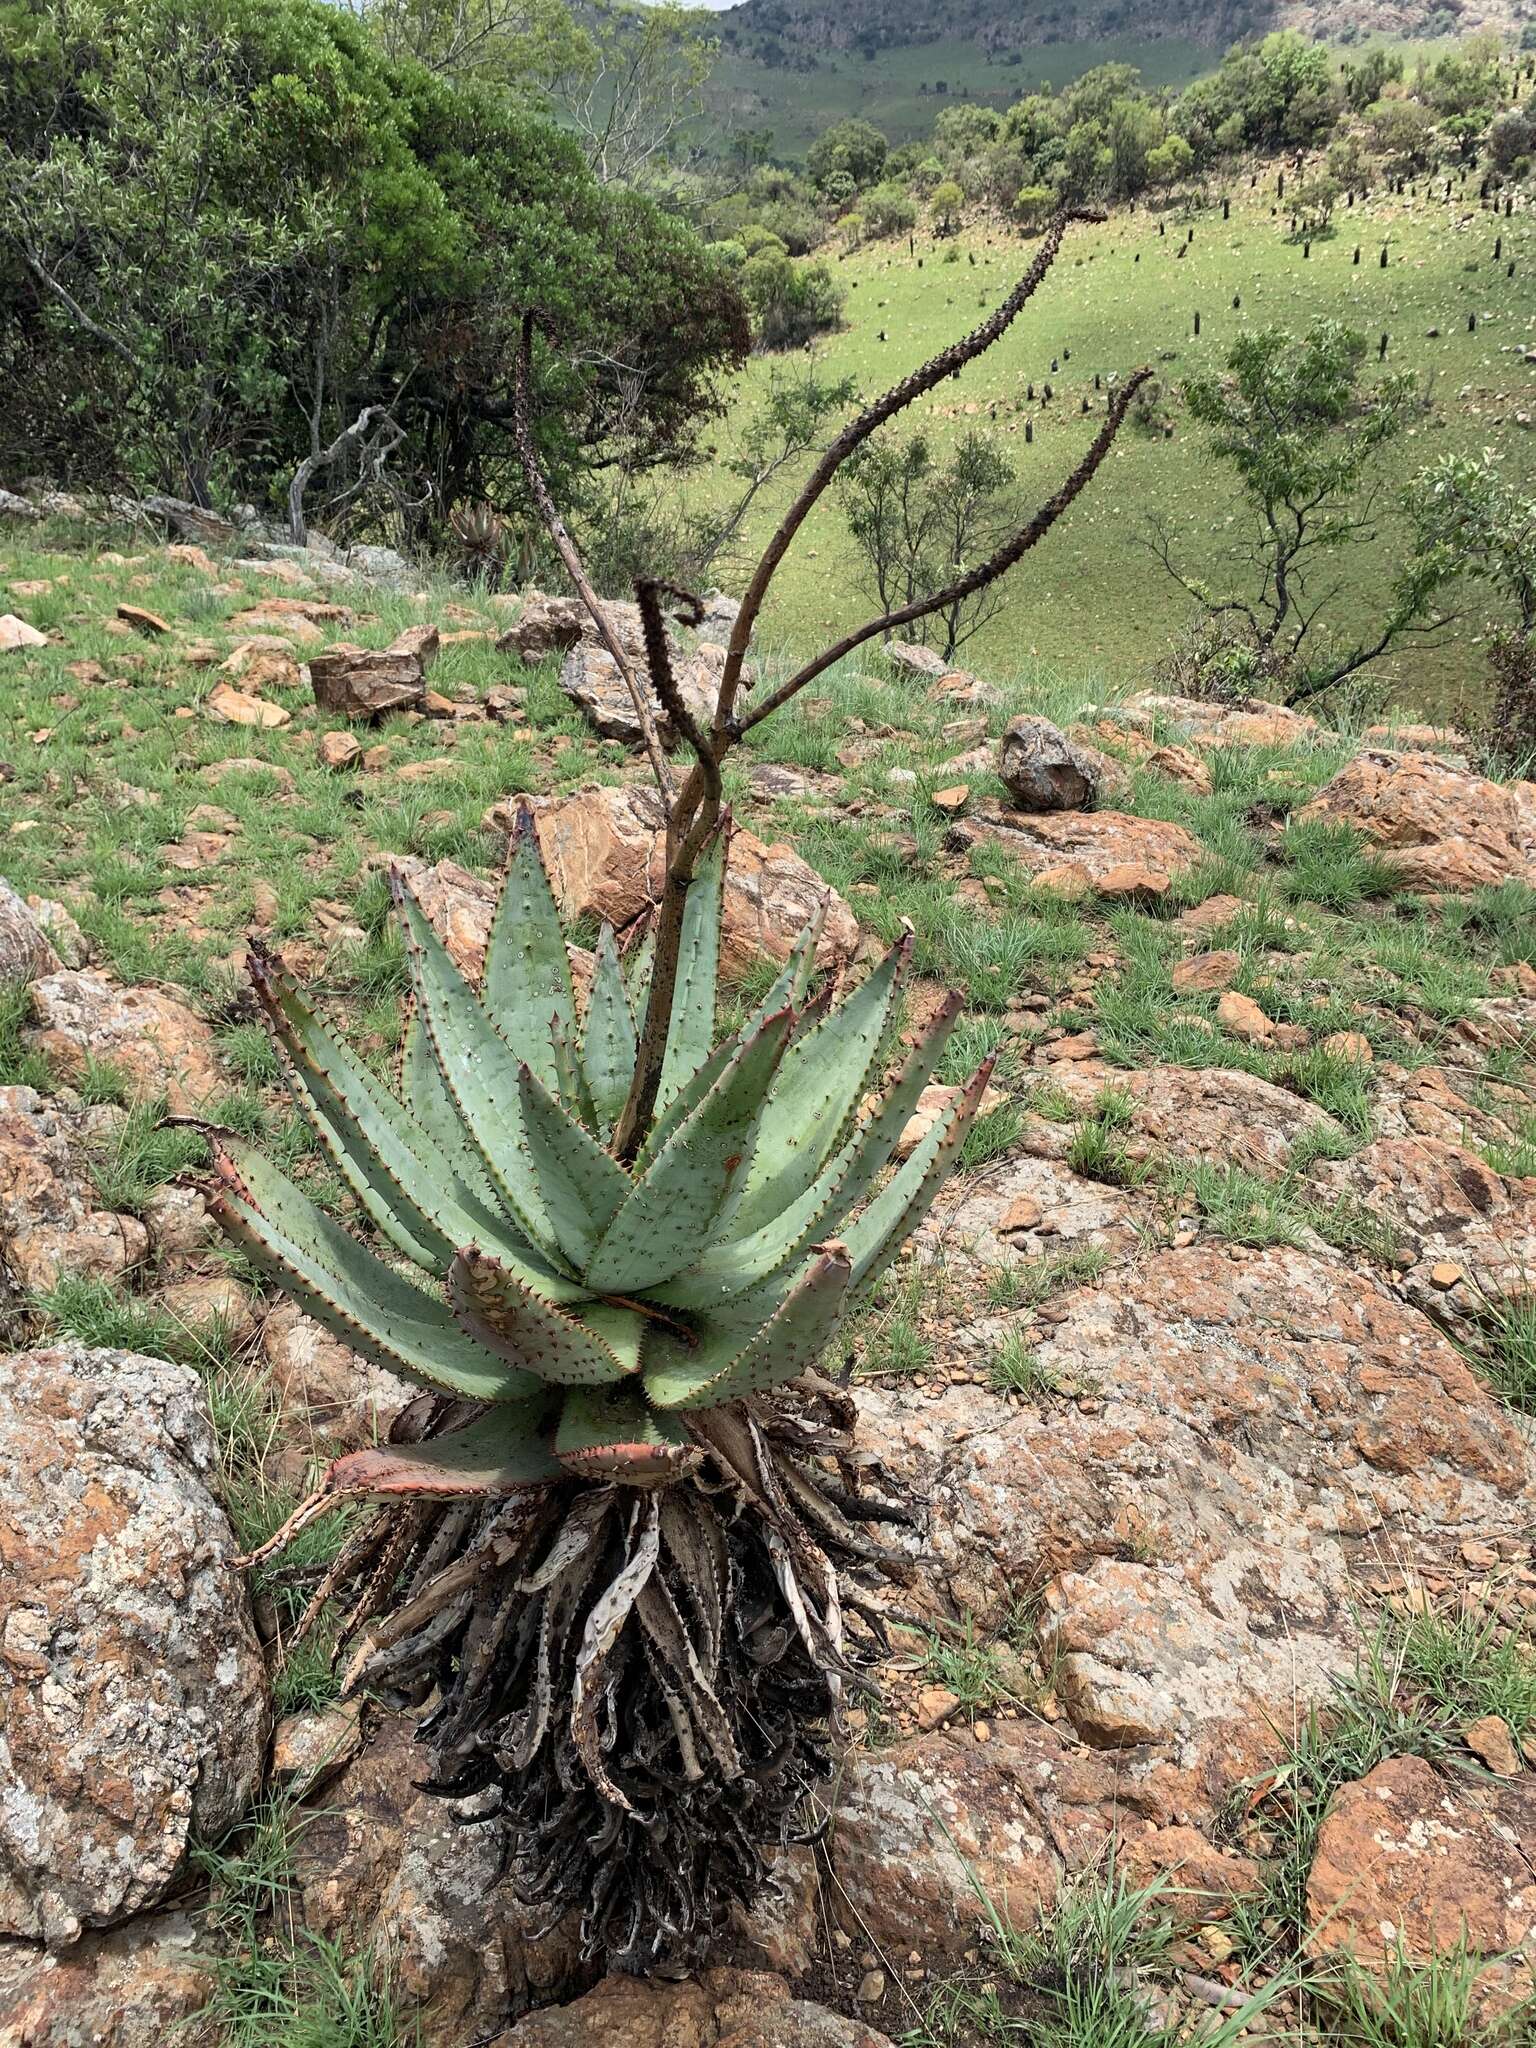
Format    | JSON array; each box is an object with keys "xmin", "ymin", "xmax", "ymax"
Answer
[{"xmin": 222, "ymin": 203, "xmax": 1139, "ymax": 1968}]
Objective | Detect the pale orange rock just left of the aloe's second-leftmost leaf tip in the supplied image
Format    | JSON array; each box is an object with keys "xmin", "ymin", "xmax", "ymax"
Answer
[{"xmin": 27, "ymin": 969, "xmax": 225, "ymax": 1116}]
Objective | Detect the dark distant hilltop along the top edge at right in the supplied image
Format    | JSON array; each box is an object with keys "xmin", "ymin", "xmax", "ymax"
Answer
[{"xmin": 719, "ymin": 0, "xmax": 1536, "ymax": 70}]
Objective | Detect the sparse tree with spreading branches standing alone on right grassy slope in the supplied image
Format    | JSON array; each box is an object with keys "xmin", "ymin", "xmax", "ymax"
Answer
[{"xmin": 1151, "ymin": 322, "xmax": 1442, "ymax": 702}]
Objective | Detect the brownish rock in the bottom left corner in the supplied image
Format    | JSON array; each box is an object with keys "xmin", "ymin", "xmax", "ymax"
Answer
[{"xmin": 0, "ymin": 1913, "xmax": 223, "ymax": 2048}]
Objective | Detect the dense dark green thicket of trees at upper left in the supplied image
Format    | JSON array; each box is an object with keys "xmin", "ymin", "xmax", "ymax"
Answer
[{"xmin": 0, "ymin": 0, "xmax": 752, "ymax": 530}]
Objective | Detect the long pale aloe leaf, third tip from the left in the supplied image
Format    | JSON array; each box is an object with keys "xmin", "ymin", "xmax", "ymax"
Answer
[{"xmin": 393, "ymin": 877, "xmax": 565, "ymax": 1268}]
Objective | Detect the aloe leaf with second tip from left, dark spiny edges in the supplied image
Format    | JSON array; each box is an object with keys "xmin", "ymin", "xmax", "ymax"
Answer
[{"xmin": 250, "ymin": 954, "xmax": 498, "ymax": 1274}]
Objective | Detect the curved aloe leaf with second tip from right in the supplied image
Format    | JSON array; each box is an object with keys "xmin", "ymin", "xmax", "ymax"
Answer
[{"xmin": 651, "ymin": 995, "xmax": 961, "ymax": 1311}]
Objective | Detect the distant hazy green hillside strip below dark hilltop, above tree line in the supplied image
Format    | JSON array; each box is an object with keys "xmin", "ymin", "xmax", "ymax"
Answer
[{"xmin": 711, "ymin": 35, "xmax": 1212, "ymax": 156}]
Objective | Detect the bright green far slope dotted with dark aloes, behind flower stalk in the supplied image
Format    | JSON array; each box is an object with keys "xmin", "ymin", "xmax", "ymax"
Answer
[{"xmin": 688, "ymin": 174, "xmax": 1536, "ymax": 711}]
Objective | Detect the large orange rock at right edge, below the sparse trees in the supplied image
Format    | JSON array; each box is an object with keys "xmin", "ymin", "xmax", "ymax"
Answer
[{"xmin": 1296, "ymin": 750, "xmax": 1536, "ymax": 895}]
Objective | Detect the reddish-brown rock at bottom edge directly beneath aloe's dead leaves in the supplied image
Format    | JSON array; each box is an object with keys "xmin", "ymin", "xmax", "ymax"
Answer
[{"xmin": 502, "ymin": 1970, "xmax": 891, "ymax": 2048}]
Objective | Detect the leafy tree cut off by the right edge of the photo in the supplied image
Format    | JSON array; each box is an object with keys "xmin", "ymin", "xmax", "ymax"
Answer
[{"xmin": 1407, "ymin": 449, "xmax": 1536, "ymax": 774}]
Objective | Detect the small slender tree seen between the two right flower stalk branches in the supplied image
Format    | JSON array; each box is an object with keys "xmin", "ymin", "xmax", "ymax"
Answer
[{"xmin": 840, "ymin": 432, "xmax": 1016, "ymax": 662}]
